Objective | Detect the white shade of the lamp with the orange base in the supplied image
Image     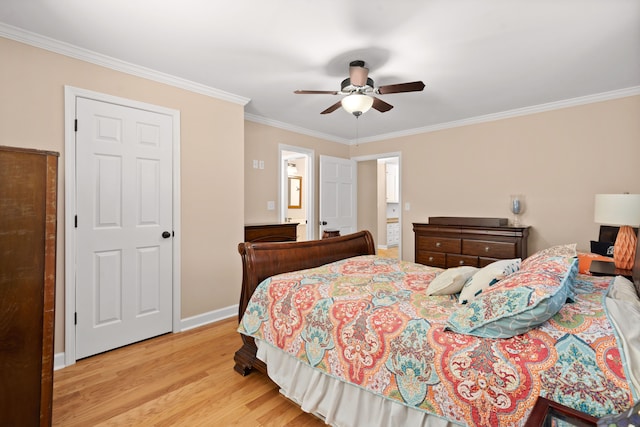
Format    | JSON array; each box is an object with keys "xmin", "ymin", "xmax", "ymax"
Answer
[{"xmin": 594, "ymin": 194, "xmax": 640, "ymax": 227}]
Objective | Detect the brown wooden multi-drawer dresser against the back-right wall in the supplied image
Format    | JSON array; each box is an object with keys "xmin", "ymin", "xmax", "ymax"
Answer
[{"xmin": 413, "ymin": 223, "xmax": 529, "ymax": 268}]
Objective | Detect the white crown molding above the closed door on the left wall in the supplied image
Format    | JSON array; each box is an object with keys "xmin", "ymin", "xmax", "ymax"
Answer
[{"xmin": 0, "ymin": 22, "xmax": 250, "ymax": 106}]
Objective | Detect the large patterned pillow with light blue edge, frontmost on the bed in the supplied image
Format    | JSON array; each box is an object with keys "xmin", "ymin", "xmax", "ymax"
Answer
[{"xmin": 445, "ymin": 257, "xmax": 578, "ymax": 338}]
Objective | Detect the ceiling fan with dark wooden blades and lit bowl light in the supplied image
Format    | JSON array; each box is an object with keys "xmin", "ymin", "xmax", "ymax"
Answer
[{"xmin": 294, "ymin": 60, "xmax": 424, "ymax": 117}]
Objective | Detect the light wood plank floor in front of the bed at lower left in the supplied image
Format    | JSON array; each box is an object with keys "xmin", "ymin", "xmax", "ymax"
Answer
[{"xmin": 53, "ymin": 318, "xmax": 325, "ymax": 427}]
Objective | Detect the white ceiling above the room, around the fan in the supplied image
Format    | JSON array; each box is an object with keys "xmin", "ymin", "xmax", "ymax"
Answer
[{"xmin": 0, "ymin": 0, "xmax": 640, "ymax": 143}]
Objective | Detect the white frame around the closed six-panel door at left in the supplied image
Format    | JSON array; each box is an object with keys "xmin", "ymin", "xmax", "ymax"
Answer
[{"xmin": 64, "ymin": 86, "xmax": 181, "ymax": 366}]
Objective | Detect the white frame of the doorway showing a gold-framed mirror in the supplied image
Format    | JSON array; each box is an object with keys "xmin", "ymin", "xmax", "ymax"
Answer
[{"xmin": 278, "ymin": 144, "xmax": 316, "ymax": 240}]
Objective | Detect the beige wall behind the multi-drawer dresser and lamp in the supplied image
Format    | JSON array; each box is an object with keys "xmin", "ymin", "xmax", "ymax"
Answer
[{"xmin": 350, "ymin": 96, "xmax": 640, "ymax": 260}]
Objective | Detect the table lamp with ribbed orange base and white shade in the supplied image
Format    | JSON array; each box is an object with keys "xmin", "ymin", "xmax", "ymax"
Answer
[{"xmin": 594, "ymin": 194, "xmax": 640, "ymax": 270}]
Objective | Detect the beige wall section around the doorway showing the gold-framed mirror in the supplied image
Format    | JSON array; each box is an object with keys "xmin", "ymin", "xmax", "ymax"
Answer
[{"xmin": 244, "ymin": 121, "xmax": 349, "ymax": 238}]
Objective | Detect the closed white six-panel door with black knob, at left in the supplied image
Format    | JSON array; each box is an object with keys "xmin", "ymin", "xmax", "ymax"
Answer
[{"xmin": 76, "ymin": 98, "xmax": 173, "ymax": 359}]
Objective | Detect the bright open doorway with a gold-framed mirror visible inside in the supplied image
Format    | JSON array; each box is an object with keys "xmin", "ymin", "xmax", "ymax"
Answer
[{"xmin": 278, "ymin": 144, "xmax": 315, "ymax": 241}]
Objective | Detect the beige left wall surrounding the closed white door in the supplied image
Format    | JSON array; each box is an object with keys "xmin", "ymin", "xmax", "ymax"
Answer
[{"xmin": 0, "ymin": 38, "xmax": 244, "ymax": 353}]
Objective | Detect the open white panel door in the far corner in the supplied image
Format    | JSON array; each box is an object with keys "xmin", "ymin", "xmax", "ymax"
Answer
[{"xmin": 320, "ymin": 156, "xmax": 358, "ymax": 236}]
